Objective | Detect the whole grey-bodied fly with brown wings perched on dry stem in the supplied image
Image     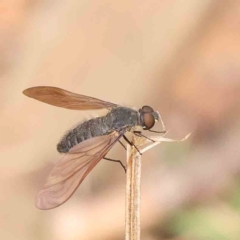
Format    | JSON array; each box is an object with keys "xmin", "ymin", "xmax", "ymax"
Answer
[{"xmin": 23, "ymin": 87, "xmax": 165, "ymax": 209}]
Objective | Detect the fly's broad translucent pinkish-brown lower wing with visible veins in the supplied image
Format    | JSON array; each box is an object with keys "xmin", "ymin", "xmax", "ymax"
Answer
[{"xmin": 36, "ymin": 132, "xmax": 122, "ymax": 209}]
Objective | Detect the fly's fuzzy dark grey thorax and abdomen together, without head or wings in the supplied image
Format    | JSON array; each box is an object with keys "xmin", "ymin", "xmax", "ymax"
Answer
[{"xmin": 57, "ymin": 107, "xmax": 139, "ymax": 153}]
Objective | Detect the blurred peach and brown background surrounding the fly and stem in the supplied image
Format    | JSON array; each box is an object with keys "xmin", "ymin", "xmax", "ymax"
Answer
[{"xmin": 0, "ymin": 0, "xmax": 240, "ymax": 240}]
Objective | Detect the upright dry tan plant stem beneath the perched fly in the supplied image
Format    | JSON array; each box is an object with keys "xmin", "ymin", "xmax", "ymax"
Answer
[{"xmin": 125, "ymin": 138, "xmax": 141, "ymax": 240}]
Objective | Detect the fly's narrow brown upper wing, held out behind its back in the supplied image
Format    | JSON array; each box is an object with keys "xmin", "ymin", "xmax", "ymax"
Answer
[{"xmin": 23, "ymin": 87, "xmax": 117, "ymax": 110}]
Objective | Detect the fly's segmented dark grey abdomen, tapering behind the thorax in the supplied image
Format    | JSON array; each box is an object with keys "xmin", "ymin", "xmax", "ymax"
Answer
[{"xmin": 57, "ymin": 117, "xmax": 109, "ymax": 153}]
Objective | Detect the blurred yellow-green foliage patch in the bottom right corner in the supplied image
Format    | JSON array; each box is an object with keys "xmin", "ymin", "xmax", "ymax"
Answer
[{"xmin": 168, "ymin": 199, "xmax": 240, "ymax": 240}]
